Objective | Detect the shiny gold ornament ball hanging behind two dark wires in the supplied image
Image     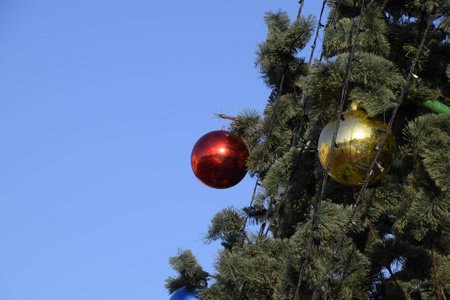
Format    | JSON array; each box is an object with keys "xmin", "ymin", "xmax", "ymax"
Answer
[{"xmin": 319, "ymin": 110, "xmax": 395, "ymax": 187}]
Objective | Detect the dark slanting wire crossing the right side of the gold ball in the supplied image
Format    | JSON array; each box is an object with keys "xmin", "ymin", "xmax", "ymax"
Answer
[{"xmin": 311, "ymin": 3, "xmax": 439, "ymax": 300}]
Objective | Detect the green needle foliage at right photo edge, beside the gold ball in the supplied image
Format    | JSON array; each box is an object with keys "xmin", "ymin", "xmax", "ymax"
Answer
[{"xmin": 394, "ymin": 115, "xmax": 450, "ymax": 250}]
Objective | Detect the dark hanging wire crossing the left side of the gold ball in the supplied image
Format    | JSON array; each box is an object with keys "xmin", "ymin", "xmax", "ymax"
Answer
[{"xmin": 293, "ymin": 0, "xmax": 374, "ymax": 300}]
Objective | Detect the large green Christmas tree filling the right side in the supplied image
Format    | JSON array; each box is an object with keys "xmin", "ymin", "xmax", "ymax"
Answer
[{"xmin": 166, "ymin": 0, "xmax": 450, "ymax": 300}]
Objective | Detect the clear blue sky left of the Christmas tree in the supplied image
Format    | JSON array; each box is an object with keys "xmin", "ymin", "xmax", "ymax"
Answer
[{"xmin": 0, "ymin": 0, "xmax": 322, "ymax": 300}]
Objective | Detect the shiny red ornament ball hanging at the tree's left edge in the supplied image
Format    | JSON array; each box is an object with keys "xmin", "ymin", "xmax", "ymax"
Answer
[{"xmin": 191, "ymin": 130, "xmax": 248, "ymax": 189}]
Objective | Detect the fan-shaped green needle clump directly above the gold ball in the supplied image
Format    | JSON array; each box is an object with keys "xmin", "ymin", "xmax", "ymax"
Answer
[{"xmin": 299, "ymin": 52, "xmax": 404, "ymax": 119}]
